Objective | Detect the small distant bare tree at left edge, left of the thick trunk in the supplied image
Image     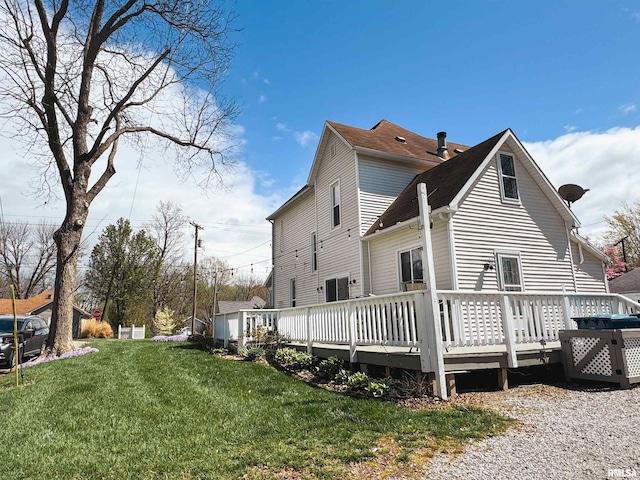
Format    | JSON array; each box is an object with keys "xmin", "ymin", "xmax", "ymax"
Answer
[{"xmin": 0, "ymin": 223, "xmax": 56, "ymax": 298}]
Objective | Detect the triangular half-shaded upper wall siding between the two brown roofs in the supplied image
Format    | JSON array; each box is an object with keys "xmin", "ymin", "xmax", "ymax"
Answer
[{"xmin": 358, "ymin": 155, "xmax": 423, "ymax": 234}]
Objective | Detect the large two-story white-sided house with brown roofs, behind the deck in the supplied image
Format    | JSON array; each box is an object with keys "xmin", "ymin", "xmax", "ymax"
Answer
[{"xmin": 268, "ymin": 120, "xmax": 607, "ymax": 308}]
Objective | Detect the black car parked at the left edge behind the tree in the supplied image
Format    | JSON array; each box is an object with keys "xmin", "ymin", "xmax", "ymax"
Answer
[{"xmin": 0, "ymin": 315, "xmax": 49, "ymax": 368}]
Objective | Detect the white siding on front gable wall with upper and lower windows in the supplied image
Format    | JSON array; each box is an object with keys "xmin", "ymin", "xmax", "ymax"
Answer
[{"xmin": 453, "ymin": 149, "xmax": 573, "ymax": 291}]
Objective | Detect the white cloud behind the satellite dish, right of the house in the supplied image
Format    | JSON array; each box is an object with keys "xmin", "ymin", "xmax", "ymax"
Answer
[{"xmin": 525, "ymin": 126, "xmax": 640, "ymax": 239}]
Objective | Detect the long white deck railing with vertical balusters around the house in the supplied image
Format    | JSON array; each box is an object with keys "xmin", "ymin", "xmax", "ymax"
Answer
[{"xmin": 214, "ymin": 290, "xmax": 640, "ymax": 363}]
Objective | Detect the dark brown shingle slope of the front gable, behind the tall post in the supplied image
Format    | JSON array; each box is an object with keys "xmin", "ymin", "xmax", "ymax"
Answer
[{"xmin": 366, "ymin": 130, "xmax": 507, "ymax": 235}]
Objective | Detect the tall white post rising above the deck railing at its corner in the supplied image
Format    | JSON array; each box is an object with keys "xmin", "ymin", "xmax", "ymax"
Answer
[{"xmin": 418, "ymin": 183, "xmax": 447, "ymax": 399}]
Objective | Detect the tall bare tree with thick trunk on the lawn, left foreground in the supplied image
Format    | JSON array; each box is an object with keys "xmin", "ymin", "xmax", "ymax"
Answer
[{"xmin": 0, "ymin": 0, "xmax": 237, "ymax": 354}]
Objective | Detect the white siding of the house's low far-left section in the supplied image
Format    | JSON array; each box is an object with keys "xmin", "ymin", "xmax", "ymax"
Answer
[{"xmin": 273, "ymin": 191, "xmax": 317, "ymax": 308}]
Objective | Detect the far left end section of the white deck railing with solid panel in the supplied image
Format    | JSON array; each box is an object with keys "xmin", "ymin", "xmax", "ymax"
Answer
[{"xmin": 213, "ymin": 309, "xmax": 278, "ymax": 347}]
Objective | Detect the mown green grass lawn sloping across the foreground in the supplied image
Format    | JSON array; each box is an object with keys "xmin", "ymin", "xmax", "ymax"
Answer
[{"xmin": 0, "ymin": 340, "xmax": 509, "ymax": 480}]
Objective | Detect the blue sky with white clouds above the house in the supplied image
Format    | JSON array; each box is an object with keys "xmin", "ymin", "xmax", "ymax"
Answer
[{"xmin": 0, "ymin": 0, "xmax": 640, "ymax": 276}]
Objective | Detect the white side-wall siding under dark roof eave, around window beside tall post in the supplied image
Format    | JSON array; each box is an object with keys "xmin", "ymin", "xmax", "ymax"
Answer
[{"xmin": 369, "ymin": 219, "xmax": 451, "ymax": 295}]
